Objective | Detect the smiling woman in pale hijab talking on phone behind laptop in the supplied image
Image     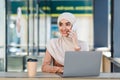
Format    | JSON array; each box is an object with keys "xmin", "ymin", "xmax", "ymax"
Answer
[{"xmin": 42, "ymin": 12, "xmax": 88, "ymax": 73}]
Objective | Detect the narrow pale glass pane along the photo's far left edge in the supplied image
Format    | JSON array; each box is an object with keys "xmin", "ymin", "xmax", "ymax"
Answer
[{"xmin": 0, "ymin": 0, "xmax": 5, "ymax": 72}]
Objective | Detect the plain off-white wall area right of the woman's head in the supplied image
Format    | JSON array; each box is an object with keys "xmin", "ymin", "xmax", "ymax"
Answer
[{"xmin": 75, "ymin": 16, "xmax": 93, "ymax": 49}]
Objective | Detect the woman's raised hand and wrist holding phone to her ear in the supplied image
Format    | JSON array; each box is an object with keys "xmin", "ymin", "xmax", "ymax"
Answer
[{"xmin": 68, "ymin": 30, "xmax": 80, "ymax": 51}]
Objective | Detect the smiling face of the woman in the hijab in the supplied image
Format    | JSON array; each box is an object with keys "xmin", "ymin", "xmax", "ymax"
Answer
[{"xmin": 58, "ymin": 19, "xmax": 72, "ymax": 37}]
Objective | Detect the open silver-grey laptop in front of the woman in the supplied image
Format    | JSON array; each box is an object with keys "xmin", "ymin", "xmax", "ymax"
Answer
[{"xmin": 62, "ymin": 51, "xmax": 102, "ymax": 77}]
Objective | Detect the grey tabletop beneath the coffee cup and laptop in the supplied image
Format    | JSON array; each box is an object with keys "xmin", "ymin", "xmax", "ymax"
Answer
[{"xmin": 0, "ymin": 72, "xmax": 120, "ymax": 79}]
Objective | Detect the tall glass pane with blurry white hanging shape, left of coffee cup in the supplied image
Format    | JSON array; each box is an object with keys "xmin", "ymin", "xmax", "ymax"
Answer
[{"xmin": 7, "ymin": 0, "xmax": 27, "ymax": 72}]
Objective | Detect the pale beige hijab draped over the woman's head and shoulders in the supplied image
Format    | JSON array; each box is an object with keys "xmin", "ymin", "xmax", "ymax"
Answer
[{"xmin": 47, "ymin": 12, "xmax": 88, "ymax": 65}]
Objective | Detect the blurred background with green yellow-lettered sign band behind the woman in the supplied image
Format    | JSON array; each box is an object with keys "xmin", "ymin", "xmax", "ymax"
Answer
[{"xmin": 0, "ymin": 0, "xmax": 110, "ymax": 72}]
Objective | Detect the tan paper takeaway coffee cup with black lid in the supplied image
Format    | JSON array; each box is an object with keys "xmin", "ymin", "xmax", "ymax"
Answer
[{"xmin": 27, "ymin": 58, "xmax": 38, "ymax": 77}]
